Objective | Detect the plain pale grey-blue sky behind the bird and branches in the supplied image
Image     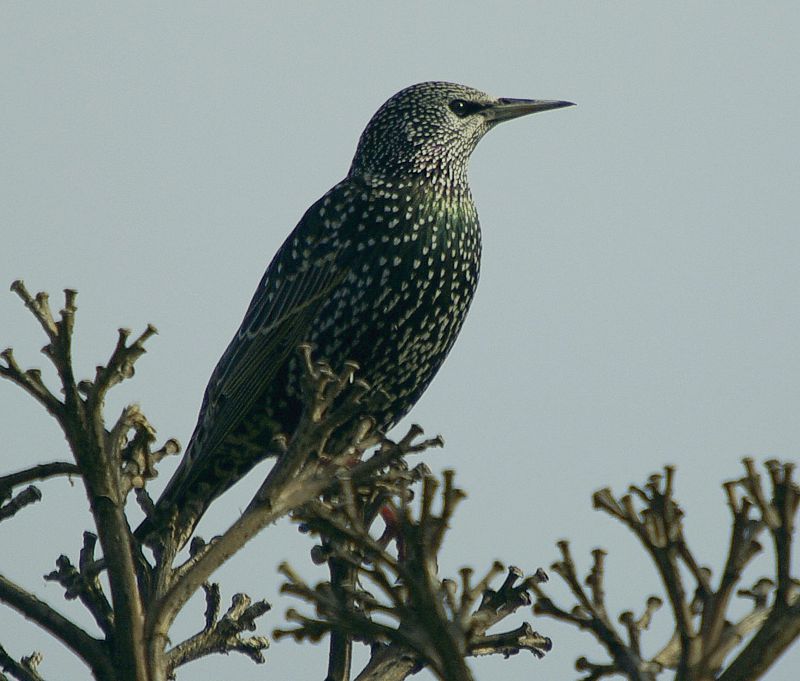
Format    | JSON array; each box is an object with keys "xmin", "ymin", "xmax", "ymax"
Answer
[{"xmin": 0, "ymin": 0, "xmax": 800, "ymax": 681}]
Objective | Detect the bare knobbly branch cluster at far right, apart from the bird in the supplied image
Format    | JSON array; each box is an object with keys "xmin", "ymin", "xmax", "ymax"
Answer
[{"xmin": 534, "ymin": 459, "xmax": 800, "ymax": 681}]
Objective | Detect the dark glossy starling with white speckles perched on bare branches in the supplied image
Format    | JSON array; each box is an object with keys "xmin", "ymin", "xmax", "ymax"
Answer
[{"xmin": 136, "ymin": 81, "xmax": 572, "ymax": 545}]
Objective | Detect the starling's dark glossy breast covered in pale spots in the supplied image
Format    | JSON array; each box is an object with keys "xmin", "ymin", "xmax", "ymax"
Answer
[{"xmin": 311, "ymin": 186, "xmax": 481, "ymax": 422}]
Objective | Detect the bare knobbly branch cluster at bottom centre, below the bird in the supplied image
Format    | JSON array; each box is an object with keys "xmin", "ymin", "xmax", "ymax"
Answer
[{"xmin": 274, "ymin": 472, "xmax": 550, "ymax": 680}]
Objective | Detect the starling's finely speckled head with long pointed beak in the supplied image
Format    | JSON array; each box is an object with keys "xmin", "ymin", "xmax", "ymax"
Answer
[{"xmin": 350, "ymin": 81, "xmax": 572, "ymax": 182}]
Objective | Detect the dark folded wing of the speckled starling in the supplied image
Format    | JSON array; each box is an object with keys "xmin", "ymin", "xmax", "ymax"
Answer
[{"xmin": 192, "ymin": 194, "xmax": 349, "ymax": 464}]
